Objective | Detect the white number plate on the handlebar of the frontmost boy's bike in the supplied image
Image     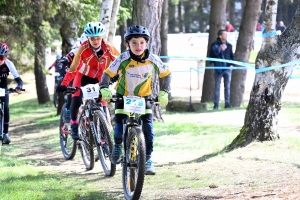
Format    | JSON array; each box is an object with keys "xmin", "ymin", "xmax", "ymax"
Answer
[{"xmin": 124, "ymin": 96, "xmax": 146, "ymax": 114}]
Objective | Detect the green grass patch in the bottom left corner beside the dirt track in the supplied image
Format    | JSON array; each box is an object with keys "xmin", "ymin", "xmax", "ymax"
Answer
[{"xmin": 0, "ymin": 171, "xmax": 121, "ymax": 200}]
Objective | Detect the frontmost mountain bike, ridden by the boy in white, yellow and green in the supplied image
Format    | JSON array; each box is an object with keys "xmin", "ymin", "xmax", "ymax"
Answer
[{"xmin": 111, "ymin": 96, "xmax": 158, "ymax": 200}]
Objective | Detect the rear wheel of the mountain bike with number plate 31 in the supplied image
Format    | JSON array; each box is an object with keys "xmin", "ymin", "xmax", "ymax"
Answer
[{"xmin": 77, "ymin": 117, "xmax": 95, "ymax": 170}]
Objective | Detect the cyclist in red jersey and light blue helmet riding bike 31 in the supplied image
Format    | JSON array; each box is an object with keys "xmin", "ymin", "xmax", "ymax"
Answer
[{"xmin": 57, "ymin": 22, "xmax": 120, "ymax": 140}]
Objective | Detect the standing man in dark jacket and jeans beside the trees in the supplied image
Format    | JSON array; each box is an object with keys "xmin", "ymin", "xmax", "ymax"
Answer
[{"xmin": 210, "ymin": 29, "xmax": 235, "ymax": 110}]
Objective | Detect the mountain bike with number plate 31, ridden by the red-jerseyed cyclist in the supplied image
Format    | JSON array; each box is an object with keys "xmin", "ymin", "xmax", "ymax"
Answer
[{"xmin": 71, "ymin": 84, "xmax": 116, "ymax": 176}]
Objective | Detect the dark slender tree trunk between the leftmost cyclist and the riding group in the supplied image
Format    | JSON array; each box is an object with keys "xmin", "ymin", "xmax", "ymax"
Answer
[{"xmin": 31, "ymin": 0, "xmax": 50, "ymax": 104}]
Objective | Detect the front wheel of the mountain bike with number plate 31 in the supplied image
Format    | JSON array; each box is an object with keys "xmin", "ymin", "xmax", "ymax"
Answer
[{"xmin": 94, "ymin": 111, "xmax": 116, "ymax": 176}]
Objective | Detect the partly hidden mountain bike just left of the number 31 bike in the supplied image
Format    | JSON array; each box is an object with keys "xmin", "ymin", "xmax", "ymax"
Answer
[{"xmin": 59, "ymin": 87, "xmax": 77, "ymax": 160}]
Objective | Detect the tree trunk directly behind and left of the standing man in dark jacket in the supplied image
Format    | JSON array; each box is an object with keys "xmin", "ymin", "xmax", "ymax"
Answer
[{"xmin": 201, "ymin": 0, "xmax": 227, "ymax": 103}]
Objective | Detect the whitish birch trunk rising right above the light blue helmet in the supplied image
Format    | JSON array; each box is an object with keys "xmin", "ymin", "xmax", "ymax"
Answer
[{"xmin": 100, "ymin": 0, "xmax": 114, "ymax": 40}]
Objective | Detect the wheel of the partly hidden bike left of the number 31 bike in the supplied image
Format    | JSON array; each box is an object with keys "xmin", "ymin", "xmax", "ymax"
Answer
[{"xmin": 59, "ymin": 104, "xmax": 76, "ymax": 160}]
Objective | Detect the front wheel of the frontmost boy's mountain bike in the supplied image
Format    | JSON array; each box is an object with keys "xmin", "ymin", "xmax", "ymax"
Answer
[{"xmin": 122, "ymin": 127, "xmax": 146, "ymax": 200}]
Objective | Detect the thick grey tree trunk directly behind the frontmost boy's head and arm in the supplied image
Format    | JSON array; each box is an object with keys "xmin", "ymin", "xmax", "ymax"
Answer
[{"xmin": 132, "ymin": 0, "xmax": 163, "ymax": 121}]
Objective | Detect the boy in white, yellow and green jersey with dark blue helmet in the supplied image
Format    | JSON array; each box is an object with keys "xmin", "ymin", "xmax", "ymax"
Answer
[{"xmin": 100, "ymin": 25, "xmax": 171, "ymax": 175}]
